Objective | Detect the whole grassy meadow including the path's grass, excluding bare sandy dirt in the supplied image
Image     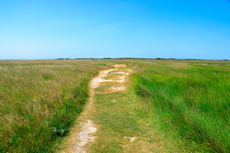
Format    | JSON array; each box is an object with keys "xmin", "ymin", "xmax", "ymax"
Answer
[{"xmin": 0, "ymin": 59, "xmax": 230, "ymax": 153}]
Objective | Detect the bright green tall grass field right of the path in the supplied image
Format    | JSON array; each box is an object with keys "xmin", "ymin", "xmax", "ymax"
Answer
[{"xmin": 132, "ymin": 61, "xmax": 230, "ymax": 152}]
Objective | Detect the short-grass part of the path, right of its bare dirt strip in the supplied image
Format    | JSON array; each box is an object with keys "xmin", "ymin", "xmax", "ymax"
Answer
[{"xmin": 89, "ymin": 65, "xmax": 164, "ymax": 153}]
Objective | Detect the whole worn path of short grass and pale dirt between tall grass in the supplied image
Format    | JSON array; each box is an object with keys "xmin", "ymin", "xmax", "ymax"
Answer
[{"xmin": 61, "ymin": 65, "xmax": 165, "ymax": 153}]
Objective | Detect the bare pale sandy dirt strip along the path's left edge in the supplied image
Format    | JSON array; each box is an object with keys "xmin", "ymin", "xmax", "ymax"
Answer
[{"xmin": 58, "ymin": 65, "xmax": 129, "ymax": 153}]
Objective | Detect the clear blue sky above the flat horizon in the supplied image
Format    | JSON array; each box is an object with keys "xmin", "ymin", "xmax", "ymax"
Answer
[{"xmin": 0, "ymin": 0, "xmax": 230, "ymax": 59}]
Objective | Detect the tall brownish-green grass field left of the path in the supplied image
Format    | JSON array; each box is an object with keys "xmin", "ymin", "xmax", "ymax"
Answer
[{"xmin": 0, "ymin": 60, "xmax": 108, "ymax": 152}]
